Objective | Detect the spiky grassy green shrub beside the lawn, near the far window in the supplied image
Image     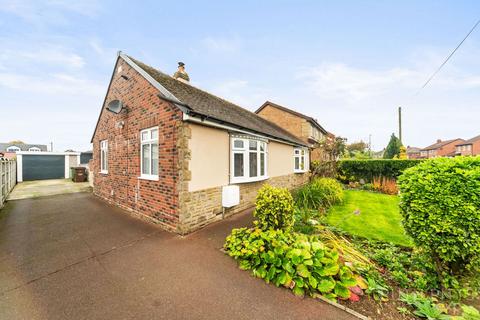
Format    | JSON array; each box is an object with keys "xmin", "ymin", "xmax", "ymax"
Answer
[{"xmin": 294, "ymin": 178, "xmax": 343, "ymax": 210}]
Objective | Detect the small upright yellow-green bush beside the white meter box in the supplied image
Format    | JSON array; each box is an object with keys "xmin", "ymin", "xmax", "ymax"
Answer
[{"xmin": 253, "ymin": 184, "xmax": 295, "ymax": 230}]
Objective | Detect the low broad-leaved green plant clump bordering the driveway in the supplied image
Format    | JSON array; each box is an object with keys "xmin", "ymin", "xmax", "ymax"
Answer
[{"xmin": 224, "ymin": 228, "xmax": 357, "ymax": 299}]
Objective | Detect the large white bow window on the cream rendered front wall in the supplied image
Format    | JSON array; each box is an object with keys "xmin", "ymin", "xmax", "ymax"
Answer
[{"xmin": 230, "ymin": 137, "xmax": 268, "ymax": 183}]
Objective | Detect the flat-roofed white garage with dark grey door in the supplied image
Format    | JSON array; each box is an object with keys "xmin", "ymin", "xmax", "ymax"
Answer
[{"xmin": 17, "ymin": 151, "xmax": 80, "ymax": 182}]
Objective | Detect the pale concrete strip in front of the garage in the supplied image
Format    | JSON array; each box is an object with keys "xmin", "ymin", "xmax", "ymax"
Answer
[{"xmin": 7, "ymin": 179, "xmax": 91, "ymax": 200}]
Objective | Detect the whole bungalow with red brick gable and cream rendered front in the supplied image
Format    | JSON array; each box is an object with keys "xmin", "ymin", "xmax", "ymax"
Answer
[{"xmin": 90, "ymin": 52, "xmax": 309, "ymax": 234}]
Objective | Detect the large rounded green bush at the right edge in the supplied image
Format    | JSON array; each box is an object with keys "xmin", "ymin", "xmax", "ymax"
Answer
[{"xmin": 398, "ymin": 157, "xmax": 480, "ymax": 280}]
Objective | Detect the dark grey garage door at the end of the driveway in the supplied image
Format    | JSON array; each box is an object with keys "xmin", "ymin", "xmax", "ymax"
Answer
[{"xmin": 22, "ymin": 155, "xmax": 65, "ymax": 181}]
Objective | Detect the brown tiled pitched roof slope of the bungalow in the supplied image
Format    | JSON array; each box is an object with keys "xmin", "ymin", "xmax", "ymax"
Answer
[{"xmin": 127, "ymin": 56, "xmax": 305, "ymax": 145}]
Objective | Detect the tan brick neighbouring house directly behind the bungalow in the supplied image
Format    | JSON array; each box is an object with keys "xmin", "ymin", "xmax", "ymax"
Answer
[{"xmin": 255, "ymin": 101, "xmax": 335, "ymax": 161}]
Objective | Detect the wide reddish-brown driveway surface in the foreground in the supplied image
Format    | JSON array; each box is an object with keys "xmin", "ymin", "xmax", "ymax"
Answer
[{"xmin": 0, "ymin": 193, "xmax": 353, "ymax": 320}]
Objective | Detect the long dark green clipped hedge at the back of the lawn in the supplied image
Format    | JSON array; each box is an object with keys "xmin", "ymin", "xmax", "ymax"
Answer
[{"xmin": 337, "ymin": 159, "xmax": 423, "ymax": 182}]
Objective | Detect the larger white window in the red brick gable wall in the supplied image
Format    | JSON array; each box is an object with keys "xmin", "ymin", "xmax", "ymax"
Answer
[{"xmin": 140, "ymin": 127, "xmax": 159, "ymax": 180}]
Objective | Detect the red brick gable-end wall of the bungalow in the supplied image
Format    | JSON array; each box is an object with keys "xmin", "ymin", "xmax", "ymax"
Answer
[{"xmin": 92, "ymin": 59, "xmax": 182, "ymax": 230}]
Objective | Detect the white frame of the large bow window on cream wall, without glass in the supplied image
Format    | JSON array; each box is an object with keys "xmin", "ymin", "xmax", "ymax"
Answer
[{"xmin": 230, "ymin": 136, "xmax": 268, "ymax": 183}]
